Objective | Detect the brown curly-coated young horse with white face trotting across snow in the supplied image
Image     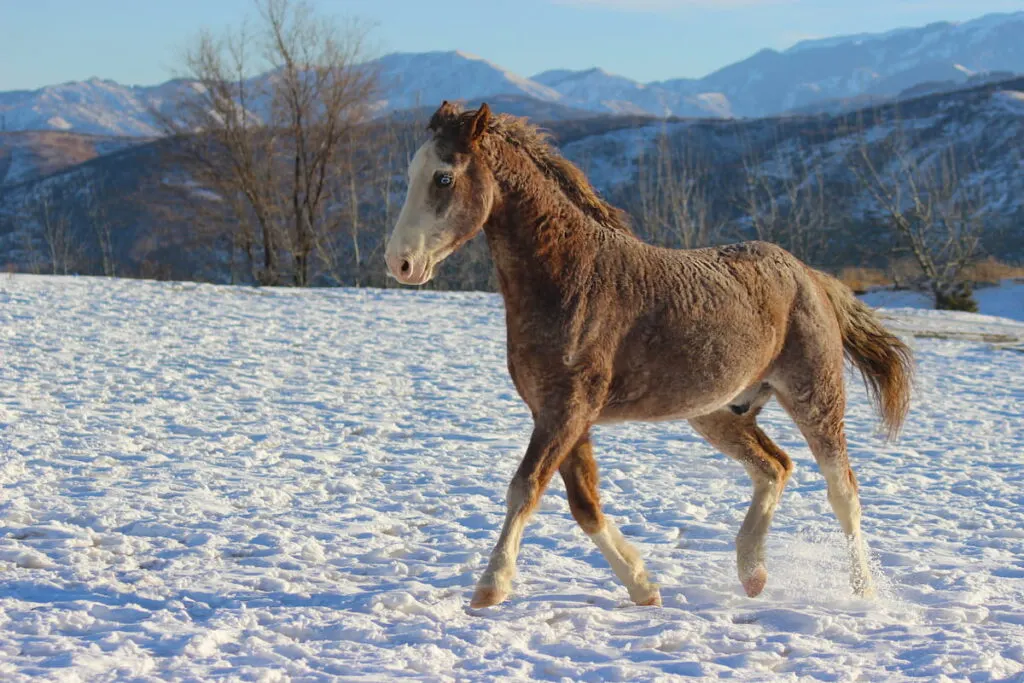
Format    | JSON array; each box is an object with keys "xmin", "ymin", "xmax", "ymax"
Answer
[{"xmin": 384, "ymin": 100, "xmax": 912, "ymax": 608}]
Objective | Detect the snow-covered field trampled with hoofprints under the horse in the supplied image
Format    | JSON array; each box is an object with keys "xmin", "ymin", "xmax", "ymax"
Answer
[{"xmin": 0, "ymin": 276, "xmax": 1024, "ymax": 681}]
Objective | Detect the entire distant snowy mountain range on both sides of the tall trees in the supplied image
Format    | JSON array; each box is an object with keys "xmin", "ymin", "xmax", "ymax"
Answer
[{"xmin": 0, "ymin": 11, "xmax": 1024, "ymax": 135}]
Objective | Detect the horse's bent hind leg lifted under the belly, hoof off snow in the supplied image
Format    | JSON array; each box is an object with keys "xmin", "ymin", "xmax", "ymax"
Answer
[{"xmin": 690, "ymin": 408, "xmax": 793, "ymax": 598}]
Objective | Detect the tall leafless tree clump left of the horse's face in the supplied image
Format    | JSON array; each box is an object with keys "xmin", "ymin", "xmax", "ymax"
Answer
[{"xmin": 159, "ymin": 0, "xmax": 377, "ymax": 286}]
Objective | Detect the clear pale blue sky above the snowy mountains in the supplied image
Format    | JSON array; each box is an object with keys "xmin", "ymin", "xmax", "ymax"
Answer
[{"xmin": 0, "ymin": 0, "xmax": 1024, "ymax": 90}]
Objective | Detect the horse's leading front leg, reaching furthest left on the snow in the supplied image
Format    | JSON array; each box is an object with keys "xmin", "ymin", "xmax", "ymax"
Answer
[{"xmin": 470, "ymin": 407, "xmax": 592, "ymax": 607}]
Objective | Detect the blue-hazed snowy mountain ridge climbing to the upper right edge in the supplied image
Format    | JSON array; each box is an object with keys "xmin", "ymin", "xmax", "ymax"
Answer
[{"xmin": 532, "ymin": 12, "xmax": 1024, "ymax": 118}]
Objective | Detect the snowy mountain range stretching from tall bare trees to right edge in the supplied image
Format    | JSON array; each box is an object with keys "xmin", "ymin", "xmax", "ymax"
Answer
[{"xmin": 370, "ymin": 12, "xmax": 1024, "ymax": 118}]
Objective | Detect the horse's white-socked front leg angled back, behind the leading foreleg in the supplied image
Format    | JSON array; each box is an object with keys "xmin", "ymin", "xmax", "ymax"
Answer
[{"xmin": 558, "ymin": 434, "xmax": 662, "ymax": 605}]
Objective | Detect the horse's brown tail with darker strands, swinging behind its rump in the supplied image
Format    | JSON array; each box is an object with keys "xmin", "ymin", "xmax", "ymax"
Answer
[{"xmin": 814, "ymin": 270, "xmax": 913, "ymax": 438}]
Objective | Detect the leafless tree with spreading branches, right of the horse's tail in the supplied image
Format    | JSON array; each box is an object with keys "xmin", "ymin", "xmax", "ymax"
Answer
[{"xmin": 850, "ymin": 111, "xmax": 985, "ymax": 309}]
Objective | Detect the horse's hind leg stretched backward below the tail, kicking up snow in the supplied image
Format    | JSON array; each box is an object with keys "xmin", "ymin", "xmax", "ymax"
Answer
[{"xmin": 776, "ymin": 356, "xmax": 874, "ymax": 597}]
